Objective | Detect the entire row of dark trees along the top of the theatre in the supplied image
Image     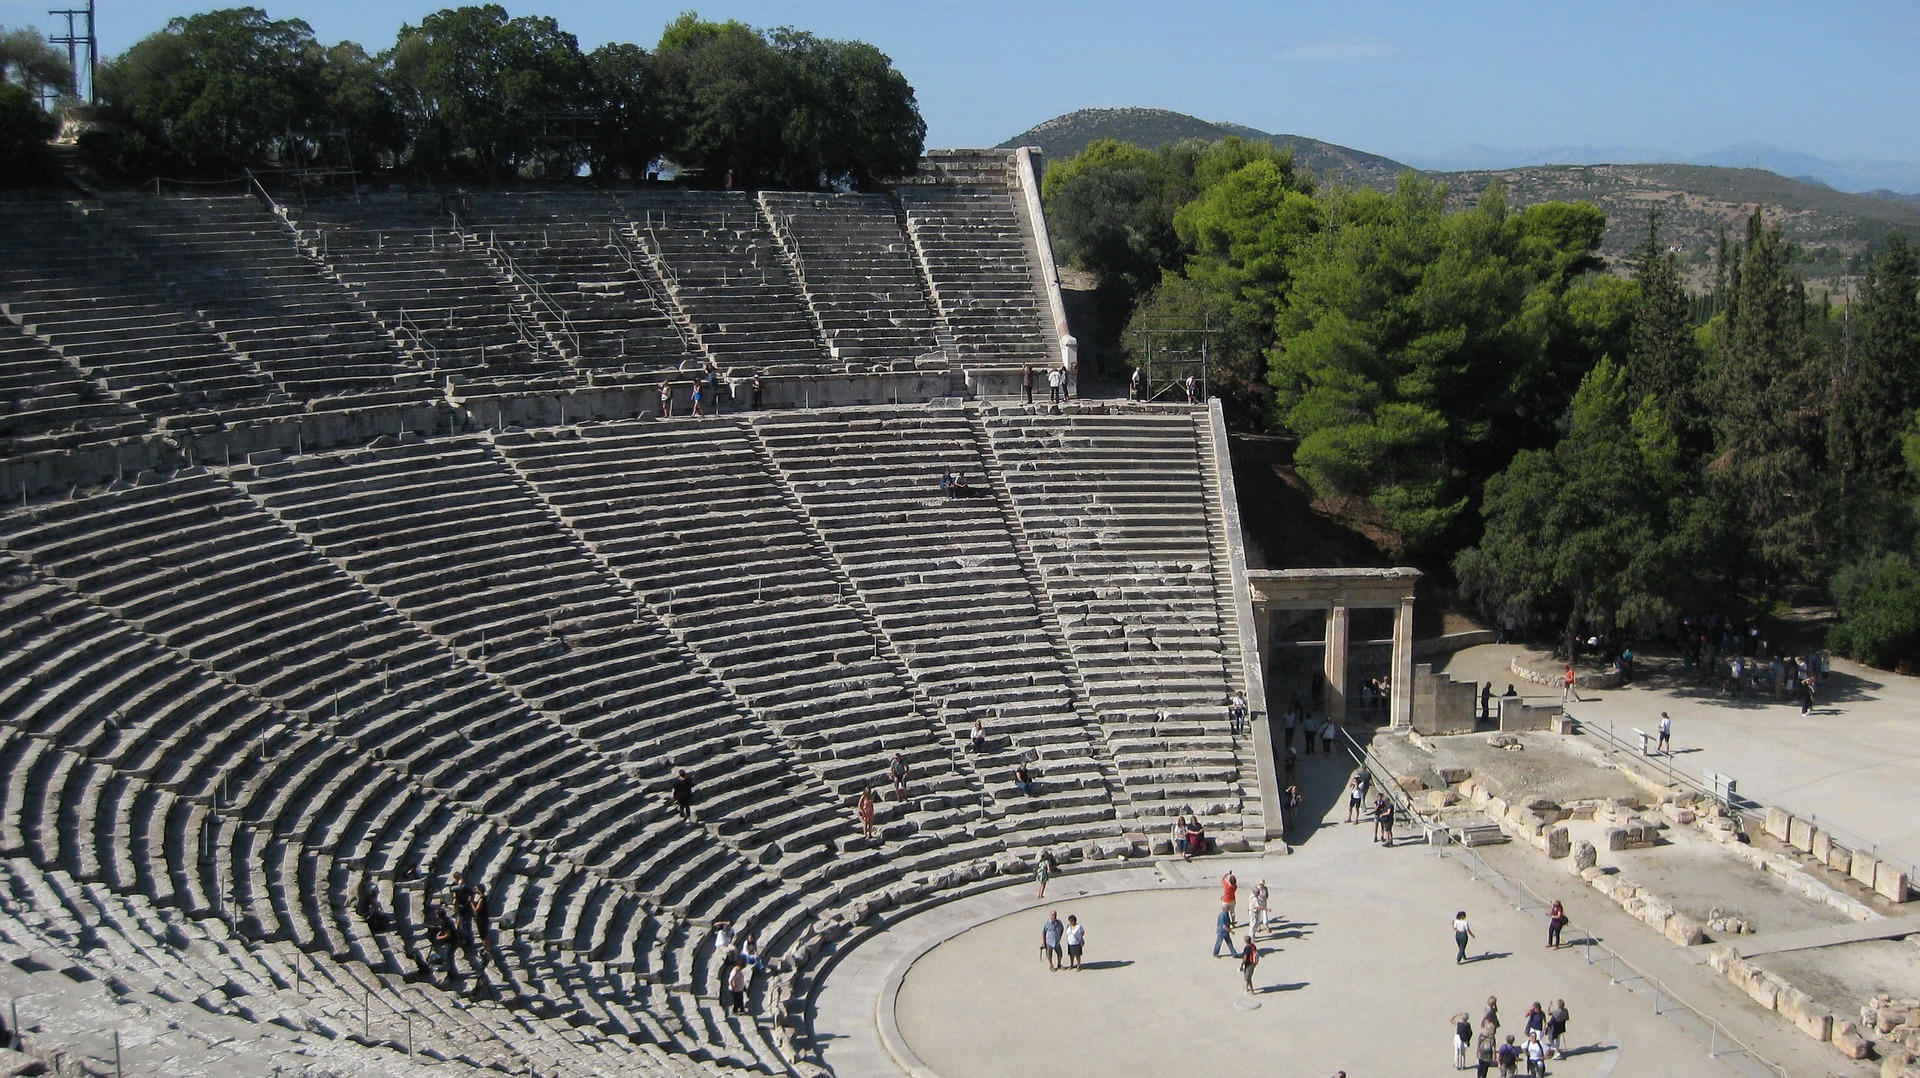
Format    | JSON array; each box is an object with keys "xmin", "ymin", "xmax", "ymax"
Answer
[{"xmin": 86, "ymin": 4, "xmax": 925, "ymax": 186}]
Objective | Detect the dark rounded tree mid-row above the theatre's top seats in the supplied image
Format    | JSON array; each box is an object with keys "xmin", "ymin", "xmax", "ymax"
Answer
[{"xmin": 386, "ymin": 4, "xmax": 591, "ymax": 181}]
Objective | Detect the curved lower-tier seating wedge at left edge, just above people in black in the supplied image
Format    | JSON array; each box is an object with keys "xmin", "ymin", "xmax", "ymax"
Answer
[{"xmin": 0, "ymin": 553, "xmax": 787, "ymax": 1063}]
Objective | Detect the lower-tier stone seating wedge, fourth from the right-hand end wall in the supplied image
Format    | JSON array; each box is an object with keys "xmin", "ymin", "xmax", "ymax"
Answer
[{"xmin": 230, "ymin": 438, "xmax": 845, "ymax": 883}]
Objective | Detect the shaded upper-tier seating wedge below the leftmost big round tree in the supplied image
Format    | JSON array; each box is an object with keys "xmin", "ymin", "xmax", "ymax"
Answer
[{"xmin": 90, "ymin": 196, "xmax": 419, "ymax": 398}]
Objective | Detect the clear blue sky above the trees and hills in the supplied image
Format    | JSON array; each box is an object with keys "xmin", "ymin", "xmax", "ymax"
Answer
[{"xmin": 0, "ymin": 0, "xmax": 1920, "ymax": 159}]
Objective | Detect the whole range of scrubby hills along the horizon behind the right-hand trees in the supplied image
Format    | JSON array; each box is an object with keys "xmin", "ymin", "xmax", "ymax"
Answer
[{"xmin": 1002, "ymin": 108, "xmax": 1920, "ymax": 288}]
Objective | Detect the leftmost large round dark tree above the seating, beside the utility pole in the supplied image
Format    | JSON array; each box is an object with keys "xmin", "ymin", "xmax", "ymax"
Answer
[{"xmin": 100, "ymin": 8, "xmax": 330, "ymax": 175}]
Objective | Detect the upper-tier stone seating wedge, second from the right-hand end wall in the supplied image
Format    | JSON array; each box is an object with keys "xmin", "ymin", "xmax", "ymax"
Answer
[{"xmin": 760, "ymin": 192, "xmax": 945, "ymax": 369}]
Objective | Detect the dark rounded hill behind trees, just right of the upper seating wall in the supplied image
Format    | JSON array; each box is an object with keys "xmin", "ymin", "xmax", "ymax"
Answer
[{"xmin": 1000, "ymin": 108, "xmax": 1411, "ymax": 186}]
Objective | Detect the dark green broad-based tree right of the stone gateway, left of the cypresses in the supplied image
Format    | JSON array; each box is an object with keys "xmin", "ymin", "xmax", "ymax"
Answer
[{"xmin": 1453, "ymin": 359, "xmax": 1690, "ymax": 653}]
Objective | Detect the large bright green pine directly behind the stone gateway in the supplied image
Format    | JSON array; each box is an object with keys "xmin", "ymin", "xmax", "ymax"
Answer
[{"xmin": 1269, "ymin": 175, "xmax": 1605, "ymax": 551}]
